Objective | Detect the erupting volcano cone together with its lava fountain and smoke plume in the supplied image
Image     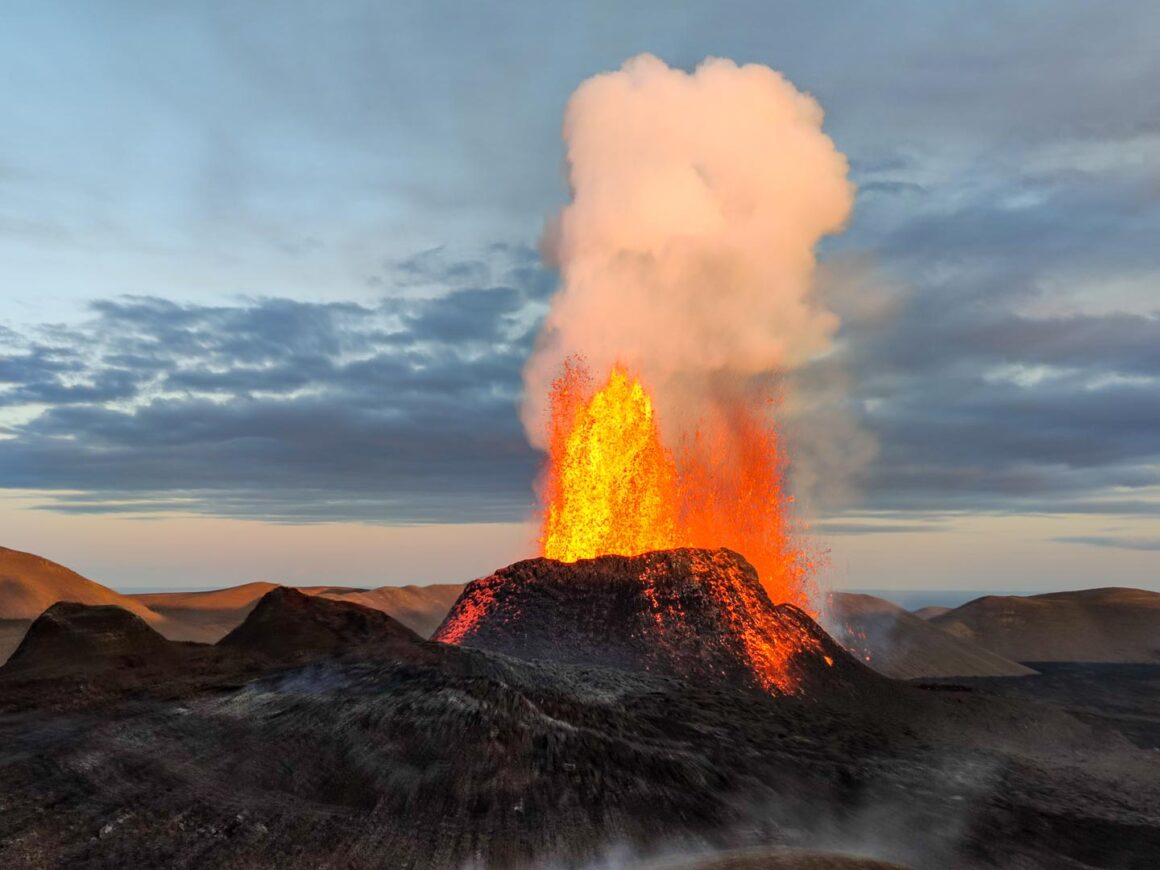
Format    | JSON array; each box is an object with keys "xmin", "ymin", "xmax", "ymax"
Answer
[{"xmin": 436, "ymin": 55, "xmax": 854, "ymax": 693}]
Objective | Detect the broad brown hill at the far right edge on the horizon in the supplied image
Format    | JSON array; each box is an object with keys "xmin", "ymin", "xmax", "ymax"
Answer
[{"xmin": 930, "ymin": 587, "xmax": 1160, "ymax": 662}]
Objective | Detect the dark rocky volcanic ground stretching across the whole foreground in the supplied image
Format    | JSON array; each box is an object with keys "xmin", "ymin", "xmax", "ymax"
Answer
[{"xmin": 0, "ymin": 554, "xmax": 1160, "ymax": 868}]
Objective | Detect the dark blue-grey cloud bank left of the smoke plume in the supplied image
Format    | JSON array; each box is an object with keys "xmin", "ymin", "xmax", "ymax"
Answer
[{"xmin": 0, "ymin": 258, "xmax": 549, "ymax": 522}]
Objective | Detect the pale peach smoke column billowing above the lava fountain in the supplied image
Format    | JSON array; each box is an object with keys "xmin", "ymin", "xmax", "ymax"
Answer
[{"xmin": 522, "ymin": 55, "xmax": 854, "ymax": 448}]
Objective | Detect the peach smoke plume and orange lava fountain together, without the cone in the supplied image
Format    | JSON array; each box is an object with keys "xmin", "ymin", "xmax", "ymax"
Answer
[{"xmin": 522, "ymin": 55, "xmax": 854, "ymax": 606}]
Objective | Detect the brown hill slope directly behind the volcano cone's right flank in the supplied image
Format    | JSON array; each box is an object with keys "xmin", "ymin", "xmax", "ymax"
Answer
[{"xmin": 829, "ymin": 592, "xmax": 1035, "ymax": 680}]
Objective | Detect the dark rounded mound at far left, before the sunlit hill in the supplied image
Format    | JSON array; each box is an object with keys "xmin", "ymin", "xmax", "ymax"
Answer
[{"xmin": 3, "ymin": 601, "xmax": 177, "ymax": 674}]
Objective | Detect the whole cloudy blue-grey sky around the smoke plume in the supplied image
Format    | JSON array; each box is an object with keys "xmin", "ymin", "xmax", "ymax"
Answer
[{"xmin": 0, "ymin": 0, "xmax": 1160, "ymax": 592}]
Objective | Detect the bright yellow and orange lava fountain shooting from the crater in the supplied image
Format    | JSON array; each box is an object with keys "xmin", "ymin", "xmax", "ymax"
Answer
[{"xmin": 541, "ymin": 361, "xmax": 815, "ymax": 615}]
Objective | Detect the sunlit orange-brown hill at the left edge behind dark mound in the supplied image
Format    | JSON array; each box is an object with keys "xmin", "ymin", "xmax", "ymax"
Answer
[{"xmin": 0, "ymin": 546, "xmax": 165, "ymax": 625}]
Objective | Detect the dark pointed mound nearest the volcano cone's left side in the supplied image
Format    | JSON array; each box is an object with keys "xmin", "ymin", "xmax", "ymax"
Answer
[{"xmin": 218, "ymin": 586, "xmax": 422, "ymax": 661}]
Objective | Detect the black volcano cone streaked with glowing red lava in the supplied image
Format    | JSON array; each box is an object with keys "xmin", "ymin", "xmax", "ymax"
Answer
[{"xmin": 433, "ymin": 549, "xmax": 878, "ymax": 694}]
